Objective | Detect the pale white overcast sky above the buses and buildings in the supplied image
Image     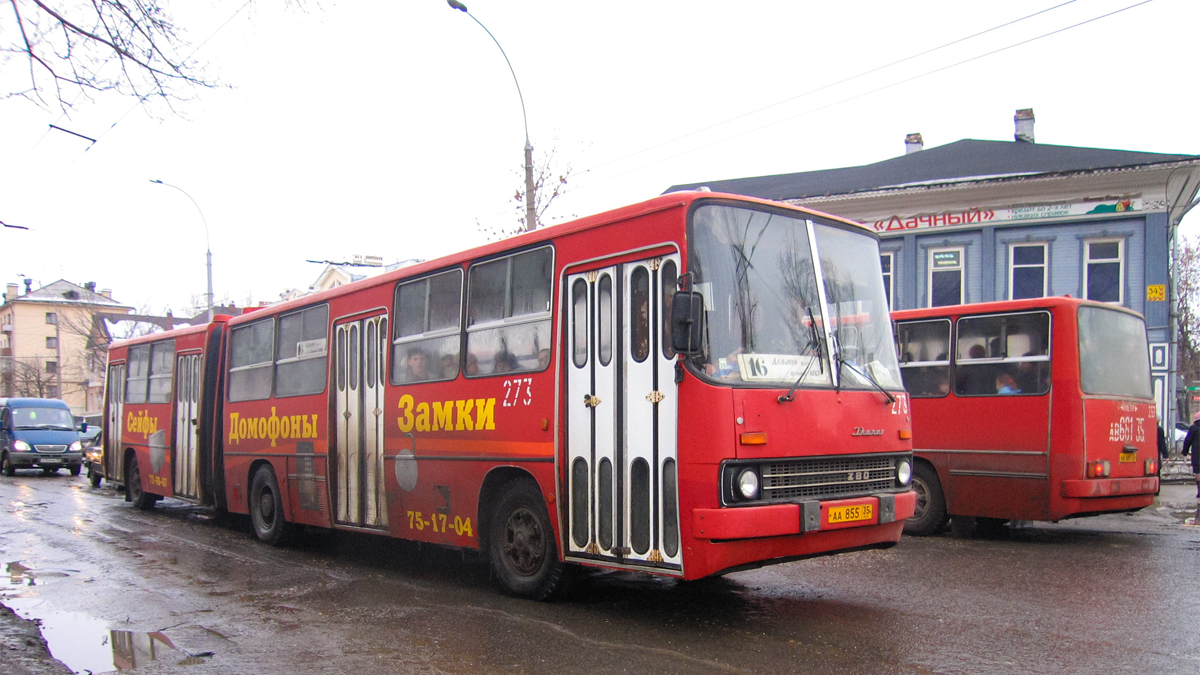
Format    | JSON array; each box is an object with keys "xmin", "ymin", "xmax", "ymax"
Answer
[{"xmin": 0, "ymin": 0, "xmax": 1200, "ymax": 312}]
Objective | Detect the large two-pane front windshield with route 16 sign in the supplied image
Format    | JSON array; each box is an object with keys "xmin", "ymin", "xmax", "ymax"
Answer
[{"xmin": 689, "ymin": 204, "xmax": 901, "ymax": 389}]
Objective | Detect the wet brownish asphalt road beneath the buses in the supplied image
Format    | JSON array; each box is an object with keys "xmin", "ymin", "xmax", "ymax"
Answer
[{"xmin": 0, "ymin": 472, "xmax": 1200, "ymax": 675}]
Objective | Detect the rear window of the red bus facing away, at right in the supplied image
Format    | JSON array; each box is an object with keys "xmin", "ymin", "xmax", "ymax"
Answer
[{"xmin": 1079, "ymin": 306, "xmax": 1152, "ymax": 399}]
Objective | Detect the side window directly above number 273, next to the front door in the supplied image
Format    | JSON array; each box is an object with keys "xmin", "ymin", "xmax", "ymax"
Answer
[{"xmin": 467, "ymin": 246, "xmax": 554, "ymax": 376}]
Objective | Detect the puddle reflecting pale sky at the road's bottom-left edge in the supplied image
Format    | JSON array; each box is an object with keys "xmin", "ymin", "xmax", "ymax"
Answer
[{"xmin": 0, "ymin": 562, "xmax": 212, "ymax": 674}]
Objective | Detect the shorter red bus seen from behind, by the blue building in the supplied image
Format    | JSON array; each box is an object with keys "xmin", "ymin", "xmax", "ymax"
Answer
[{"xmin": 892, "ymin": 297, "xmax": 1158, "ymax": 534}]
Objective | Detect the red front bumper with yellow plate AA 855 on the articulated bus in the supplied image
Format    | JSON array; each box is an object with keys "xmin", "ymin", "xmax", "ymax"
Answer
[{"xmin": 691, "ymin": 490, "xmax": 917, "ymax": 540}]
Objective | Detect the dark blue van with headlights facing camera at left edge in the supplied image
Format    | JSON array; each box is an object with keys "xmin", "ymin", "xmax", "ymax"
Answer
[{"xmin": 0, "ymin": 399, "xmax": 83, "ymax": 476}]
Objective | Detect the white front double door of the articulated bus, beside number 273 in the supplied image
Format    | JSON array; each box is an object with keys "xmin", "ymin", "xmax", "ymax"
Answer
[{"xmin": 564, "ymin": 256, "xmax": 683, "ymax": 569}]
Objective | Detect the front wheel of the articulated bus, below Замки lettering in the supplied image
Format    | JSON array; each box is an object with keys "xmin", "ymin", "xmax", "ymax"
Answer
[{"xmin": 487, "ymin": 479, "xmax": 566, "ymax": 601}]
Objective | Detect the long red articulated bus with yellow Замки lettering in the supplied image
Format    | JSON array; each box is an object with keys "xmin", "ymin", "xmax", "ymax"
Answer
[{"xmin": 104, "ymin": 192, "xmax": 917, "ymax": 598}]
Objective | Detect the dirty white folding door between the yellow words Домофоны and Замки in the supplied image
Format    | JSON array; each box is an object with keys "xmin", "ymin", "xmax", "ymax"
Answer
[{"xmin": 334, "ymin": 315, "xmax": 389, "ymax": 528}]
